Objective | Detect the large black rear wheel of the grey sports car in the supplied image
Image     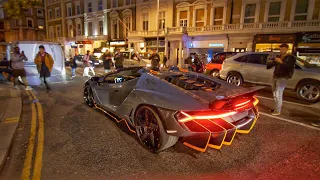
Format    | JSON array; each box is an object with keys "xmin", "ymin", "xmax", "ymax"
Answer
[{"xmin": 134, "ymin": 105, "xmax": 178, "ymax": 153}]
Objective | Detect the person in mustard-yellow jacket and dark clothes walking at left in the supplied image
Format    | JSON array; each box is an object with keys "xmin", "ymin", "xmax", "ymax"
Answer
[{"xmin": 34, "ymin": 45, "xmax": 54, "ymax": 92}]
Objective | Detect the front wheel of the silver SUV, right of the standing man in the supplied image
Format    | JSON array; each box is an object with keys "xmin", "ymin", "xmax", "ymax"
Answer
[{"xmin": 297, "ymin": 81, "xmax": 320, "ymax": 103}]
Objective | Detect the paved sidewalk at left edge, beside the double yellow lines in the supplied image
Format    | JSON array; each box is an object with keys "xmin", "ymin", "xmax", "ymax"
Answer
[{"xmin": 0, "ymin": 82, "xmax": 22, "ymax": 171}]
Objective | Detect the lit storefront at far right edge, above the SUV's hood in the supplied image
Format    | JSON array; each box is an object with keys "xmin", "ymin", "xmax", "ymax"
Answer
[{"xmin": 297, "ymin": 32, "xmax": 320, "ymax": 66}]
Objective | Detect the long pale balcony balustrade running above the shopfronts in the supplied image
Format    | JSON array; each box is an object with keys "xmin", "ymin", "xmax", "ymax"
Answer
[{"xmin": 129, "ymin": 20, "xmax": 320, "ymax": 37}]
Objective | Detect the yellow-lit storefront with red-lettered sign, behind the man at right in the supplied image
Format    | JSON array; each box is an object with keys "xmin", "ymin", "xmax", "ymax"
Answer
[{"xmin": 254, "ymin": 34, "xmax": 296, "ymax": 53}]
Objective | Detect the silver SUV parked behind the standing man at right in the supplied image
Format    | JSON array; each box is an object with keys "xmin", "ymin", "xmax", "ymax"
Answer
[{"xmin": 220, "ymin": 52, "xmax": 320, "ymax": 103}]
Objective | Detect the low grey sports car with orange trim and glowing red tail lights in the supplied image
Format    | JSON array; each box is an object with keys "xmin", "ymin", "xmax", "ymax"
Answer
[{"xmin": 84, "ymin": 67, "xmax": 262, "ymax": 153}]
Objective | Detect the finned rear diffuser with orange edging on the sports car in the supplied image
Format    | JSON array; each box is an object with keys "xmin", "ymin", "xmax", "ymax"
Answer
[{"xmin": 182, "ymin": 108, "xmax": 259, "ymax": 152}]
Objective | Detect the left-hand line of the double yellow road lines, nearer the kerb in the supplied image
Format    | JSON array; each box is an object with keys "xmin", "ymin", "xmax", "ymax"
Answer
[{"xmin": 21, "ymin": 94, "xmax": 37, "ymax": 180}]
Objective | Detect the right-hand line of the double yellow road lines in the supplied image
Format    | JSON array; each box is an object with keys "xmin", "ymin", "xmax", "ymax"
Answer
[{"xmin": 32, "ymin": 102, "xmax": 44, "ymax": 180}]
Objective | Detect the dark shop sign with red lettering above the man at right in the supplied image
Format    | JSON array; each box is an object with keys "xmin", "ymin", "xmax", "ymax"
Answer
[{"xmin": 255, "ymin": 34, "xmax": 295, "ymax": 43}]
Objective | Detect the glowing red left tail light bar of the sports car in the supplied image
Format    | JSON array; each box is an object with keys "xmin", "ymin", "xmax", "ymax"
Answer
[{"xmin": 176, "ymin": 111, "xmax": 237, "ymax": 123}]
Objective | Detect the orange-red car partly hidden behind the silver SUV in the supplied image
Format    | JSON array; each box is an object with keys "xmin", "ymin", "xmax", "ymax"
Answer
[{"xmin": 205, "ymin": 52, "xmax": 237, "ymax": 77}]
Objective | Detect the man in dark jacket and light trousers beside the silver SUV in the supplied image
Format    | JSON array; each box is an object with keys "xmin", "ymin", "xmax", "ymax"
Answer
[{"xmin": 267, "ymin": 44, "xmax": 296, "ymax": 116}]
